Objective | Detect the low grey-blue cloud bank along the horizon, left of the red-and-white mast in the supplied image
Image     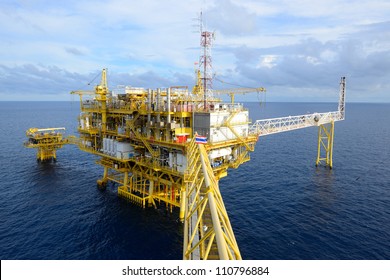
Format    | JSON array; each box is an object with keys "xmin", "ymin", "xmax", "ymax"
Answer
[{"xmin": 0, "ymin": 64, "xmax": 192, "ymax": 100}]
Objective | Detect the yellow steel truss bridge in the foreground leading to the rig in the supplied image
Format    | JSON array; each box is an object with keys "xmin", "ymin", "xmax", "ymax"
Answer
[{"xmin": 183, "ymin": 137, "xmax": 241, "ymax": 260}]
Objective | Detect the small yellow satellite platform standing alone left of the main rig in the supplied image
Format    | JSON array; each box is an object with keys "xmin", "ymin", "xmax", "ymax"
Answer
[{"xmin": 24, "ymin": 127, "xmax": 68, "ymax": 162}]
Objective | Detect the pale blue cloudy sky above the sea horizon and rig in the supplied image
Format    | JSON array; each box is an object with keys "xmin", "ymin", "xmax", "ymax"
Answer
[{"xmin": 0, "ymin": 0, "xmax": 390, "ymax": 103}]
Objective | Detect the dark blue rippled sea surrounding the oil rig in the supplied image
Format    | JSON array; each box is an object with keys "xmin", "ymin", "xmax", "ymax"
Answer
[{"xmin": 0, "ymin": 101, "xmax": 390, "ymax": 260}]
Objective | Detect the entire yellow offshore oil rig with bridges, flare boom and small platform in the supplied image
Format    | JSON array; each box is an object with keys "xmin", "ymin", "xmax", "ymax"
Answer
[{"xmin": 25, "ymin": 31, "xmax": 345, "ymax": 260}]
